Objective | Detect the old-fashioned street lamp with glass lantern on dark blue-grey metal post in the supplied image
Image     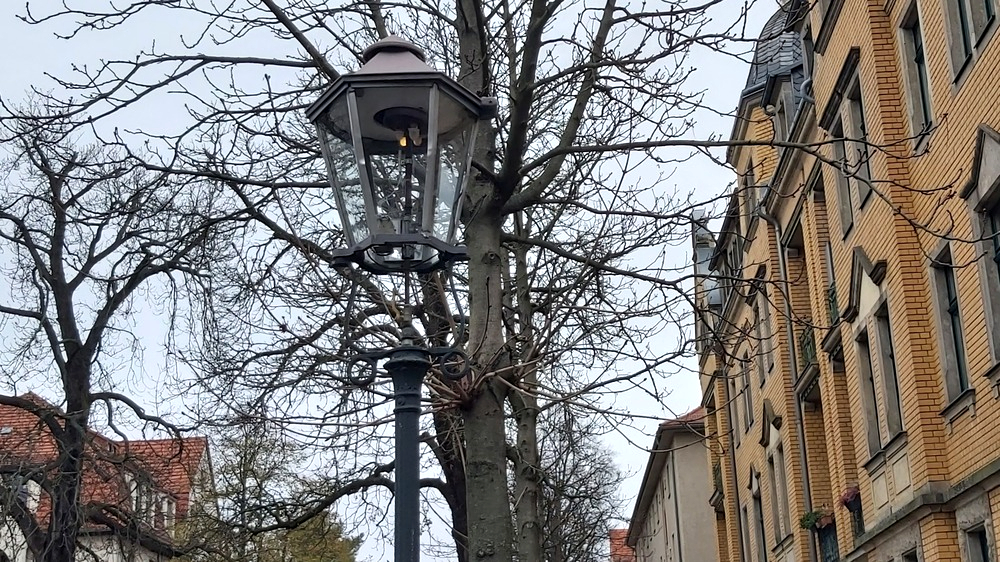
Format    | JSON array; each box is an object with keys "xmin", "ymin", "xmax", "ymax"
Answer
[{"xmin": 307, "ymin": 37, "xmax": 496, "ymax": 562}]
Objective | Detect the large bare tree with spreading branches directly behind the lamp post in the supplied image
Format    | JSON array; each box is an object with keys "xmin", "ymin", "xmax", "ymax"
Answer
[{"xmin": 0, "ymin": 0, "xmax": 812, "ymax": 561}]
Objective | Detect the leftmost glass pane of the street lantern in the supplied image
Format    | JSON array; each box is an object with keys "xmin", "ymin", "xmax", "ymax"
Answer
[{"xmin": 319, "ymin": 116, "xmax": 369, "ymax": 246}]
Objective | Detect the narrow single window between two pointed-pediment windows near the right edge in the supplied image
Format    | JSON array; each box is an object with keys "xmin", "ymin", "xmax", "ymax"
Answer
[{"xmin": 933, "ymin": 248, "xmax": 969, "ymax": 402}]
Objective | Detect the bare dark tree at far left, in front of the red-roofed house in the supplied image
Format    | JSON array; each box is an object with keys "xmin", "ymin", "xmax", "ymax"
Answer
[{"xmin": 0, "ymin": 115, "xmax": 242, "ymax": 561}]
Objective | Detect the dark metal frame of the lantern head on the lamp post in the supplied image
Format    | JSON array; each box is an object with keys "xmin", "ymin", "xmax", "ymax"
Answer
[{"xmin": 306, "ymin": 36, "xmax": 497, "ymax": 274}]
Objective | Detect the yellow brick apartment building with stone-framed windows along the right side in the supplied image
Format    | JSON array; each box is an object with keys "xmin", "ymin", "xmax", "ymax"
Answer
[{"xmin": 693, "ymin": 0, "xmax": 1000, "ymax": 562}]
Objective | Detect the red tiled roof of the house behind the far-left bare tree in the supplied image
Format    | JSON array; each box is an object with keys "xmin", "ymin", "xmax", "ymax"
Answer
[{"xmin": 0, "ymin": 393, "xmax": 208, "ymax": 531}]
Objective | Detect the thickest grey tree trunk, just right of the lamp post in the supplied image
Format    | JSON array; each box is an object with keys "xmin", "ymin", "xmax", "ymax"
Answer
[{"xmin": 456, "ymin": 0, "xmax": 514, "ymax": 552}]
